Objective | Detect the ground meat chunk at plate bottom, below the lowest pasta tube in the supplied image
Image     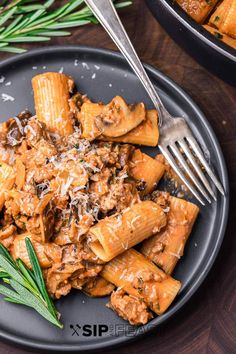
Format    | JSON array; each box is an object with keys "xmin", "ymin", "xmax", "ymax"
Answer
[{"xmin": 108, "ymin": 290, "xmax": 152, "ymax": 325}]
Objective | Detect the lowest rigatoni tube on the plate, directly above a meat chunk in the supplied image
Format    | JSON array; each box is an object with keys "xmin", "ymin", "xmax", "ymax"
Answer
[{"xmin": 100, "ymin": 248, "xmax": 181, "ymax": 315}]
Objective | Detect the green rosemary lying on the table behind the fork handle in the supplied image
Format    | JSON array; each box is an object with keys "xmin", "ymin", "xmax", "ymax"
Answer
[{"xmin": 0, "ymin": 0, "xmax": 132, "ymax": 53}]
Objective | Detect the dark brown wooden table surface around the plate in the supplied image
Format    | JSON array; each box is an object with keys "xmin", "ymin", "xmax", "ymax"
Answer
[{"xmin": 0, "ymin": 0, "xmax": 236, "ymax": 354}]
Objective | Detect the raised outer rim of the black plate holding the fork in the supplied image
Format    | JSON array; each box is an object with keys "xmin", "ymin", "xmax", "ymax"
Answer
[{"xmin": 0, "ymin": 45, "xmax": 229, "ymax": 352}]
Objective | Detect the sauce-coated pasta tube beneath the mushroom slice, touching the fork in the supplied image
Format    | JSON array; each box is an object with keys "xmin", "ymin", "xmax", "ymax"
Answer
[{"xmin": 99, "ymin": 109, "xmax": 159, "ymax": 146}]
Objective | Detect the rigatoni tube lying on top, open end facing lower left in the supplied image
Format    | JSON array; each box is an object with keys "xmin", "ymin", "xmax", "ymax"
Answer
[{"xmin": 89, "ymin": 201, "xmax": 166, "ymax": 262}]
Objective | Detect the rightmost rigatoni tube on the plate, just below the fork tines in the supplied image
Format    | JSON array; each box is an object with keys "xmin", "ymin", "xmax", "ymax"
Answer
[{"xmin": 140, "ymin": 197, "xmax": 199, "ymax": 274}]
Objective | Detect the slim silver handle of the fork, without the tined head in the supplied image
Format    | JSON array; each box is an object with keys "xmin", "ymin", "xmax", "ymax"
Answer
[{"xmin": 85, "ymin": 0, "xmax": 165, "ymax": 126}]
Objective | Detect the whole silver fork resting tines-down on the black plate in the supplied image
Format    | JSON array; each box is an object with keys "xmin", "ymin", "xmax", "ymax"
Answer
[{"xmin": 85, "ymin": 0, "xmax": 224, "ymax": 205}]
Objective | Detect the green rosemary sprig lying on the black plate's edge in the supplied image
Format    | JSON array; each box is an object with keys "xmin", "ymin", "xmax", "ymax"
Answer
[{"xmin": 0, "ymin": 238, "xmax": 63, "ymax": 328}]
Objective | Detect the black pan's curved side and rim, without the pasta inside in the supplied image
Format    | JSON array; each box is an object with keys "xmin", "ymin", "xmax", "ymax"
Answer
[{"xmin": 146, "ymin": 0, "xmax": 236, "ymax": 85}]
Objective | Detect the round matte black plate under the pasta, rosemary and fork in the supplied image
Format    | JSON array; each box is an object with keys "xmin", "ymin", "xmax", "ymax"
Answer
[{"xmin": 0, "ymin": 46, "xmax": 228, "ymax": 352}]
